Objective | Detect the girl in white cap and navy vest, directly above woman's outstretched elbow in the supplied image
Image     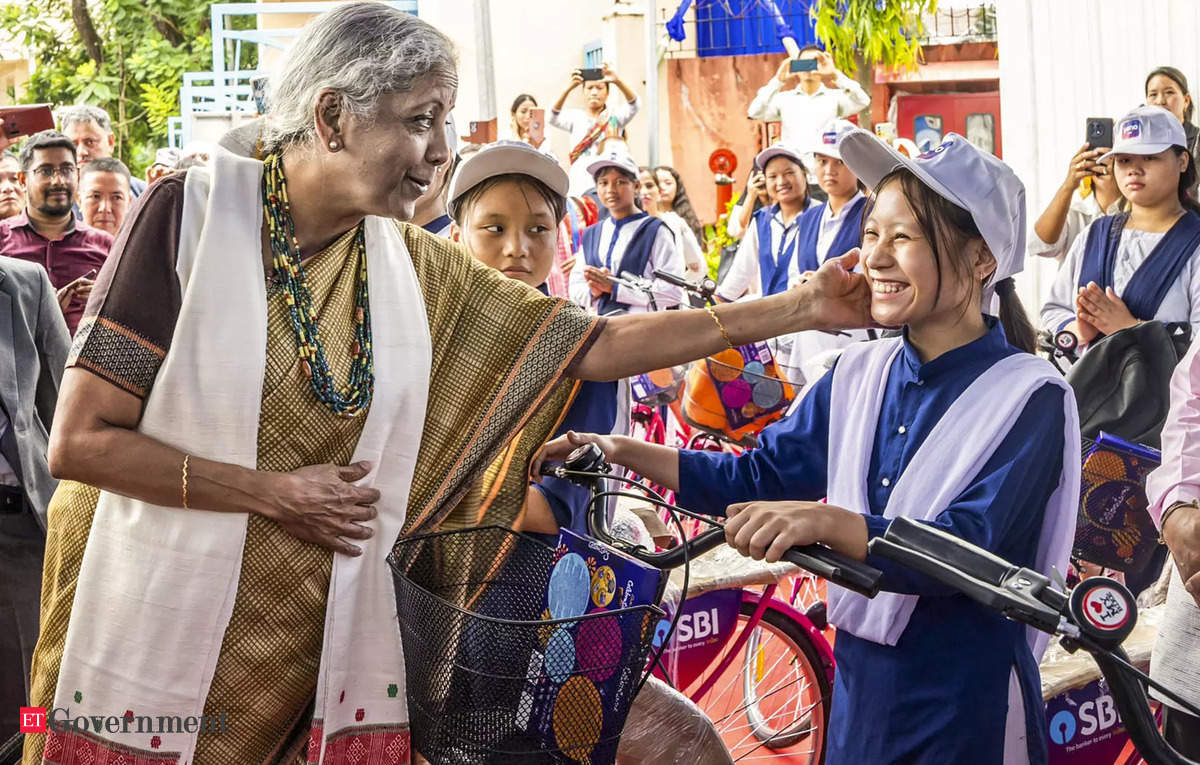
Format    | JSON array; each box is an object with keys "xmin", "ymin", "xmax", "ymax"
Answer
[{"xmin": 570, "ymin": 152, "xmax": 684, "ymax": 315}]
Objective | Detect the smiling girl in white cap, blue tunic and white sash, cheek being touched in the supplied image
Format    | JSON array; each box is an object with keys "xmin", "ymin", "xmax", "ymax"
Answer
[{"xmin": 545, "ymin": 131, "xmax": 1080, "ymax": 765}]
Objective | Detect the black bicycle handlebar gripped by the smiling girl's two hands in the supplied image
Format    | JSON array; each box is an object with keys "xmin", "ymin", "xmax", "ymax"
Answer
[{"xmin": 541, "ymin": 444, "xmax": 883, "ymax": 597}]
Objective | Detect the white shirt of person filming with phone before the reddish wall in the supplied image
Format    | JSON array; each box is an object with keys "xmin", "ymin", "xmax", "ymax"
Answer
[{"xmin": 746, "ymin": 72, "xmax": 871, "ymax": 160}]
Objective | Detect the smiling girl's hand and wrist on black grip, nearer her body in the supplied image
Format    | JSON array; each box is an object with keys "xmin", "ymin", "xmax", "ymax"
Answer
[{"xmin": 725, "ymin": 501, "xmax": 868, "ymax": 564}]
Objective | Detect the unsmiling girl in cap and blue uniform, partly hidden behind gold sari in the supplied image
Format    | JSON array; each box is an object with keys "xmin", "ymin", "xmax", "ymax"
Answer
[{"xmin": 450, "ymin": 140, "xmax": 618, "ymax": 542}]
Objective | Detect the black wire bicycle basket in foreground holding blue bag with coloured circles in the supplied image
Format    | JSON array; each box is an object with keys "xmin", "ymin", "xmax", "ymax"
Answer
[{"xmin": 388, "ymin": 526, "xmax": 662, "ymax": 765}]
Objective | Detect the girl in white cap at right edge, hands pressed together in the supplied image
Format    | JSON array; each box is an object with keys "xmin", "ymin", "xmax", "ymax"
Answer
[{"xmin": 1042, "ymin": 106, "xmax": 1200, "ymax": 344}]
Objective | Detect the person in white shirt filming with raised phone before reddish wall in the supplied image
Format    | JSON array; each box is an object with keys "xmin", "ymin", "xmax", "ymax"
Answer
[{"xmin": 746, "ymin": 46, "xmax": 871, "ymax": 187}]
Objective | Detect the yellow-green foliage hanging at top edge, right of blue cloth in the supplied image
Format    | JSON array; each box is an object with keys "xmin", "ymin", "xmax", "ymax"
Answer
[{"xmin": 811, "ymin": 0, "xmax": 937, "ymax": 74}]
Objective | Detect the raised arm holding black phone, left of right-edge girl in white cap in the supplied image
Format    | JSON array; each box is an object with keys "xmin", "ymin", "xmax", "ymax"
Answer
[{"xmin": 1026, "ymin": 118, "xmax": 1124, "ymax": 263}]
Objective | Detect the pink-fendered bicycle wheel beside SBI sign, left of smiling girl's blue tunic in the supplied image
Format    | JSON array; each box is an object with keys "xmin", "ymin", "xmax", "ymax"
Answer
[{"xmin": 684, "ymin": 601, "xmax": 832, "ymax": 765}]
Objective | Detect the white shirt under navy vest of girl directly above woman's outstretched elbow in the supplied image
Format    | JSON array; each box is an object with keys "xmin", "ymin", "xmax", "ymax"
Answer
[{"xmin": 569, "ymin": 216, "xmax": 684, "ymax": 313}]
